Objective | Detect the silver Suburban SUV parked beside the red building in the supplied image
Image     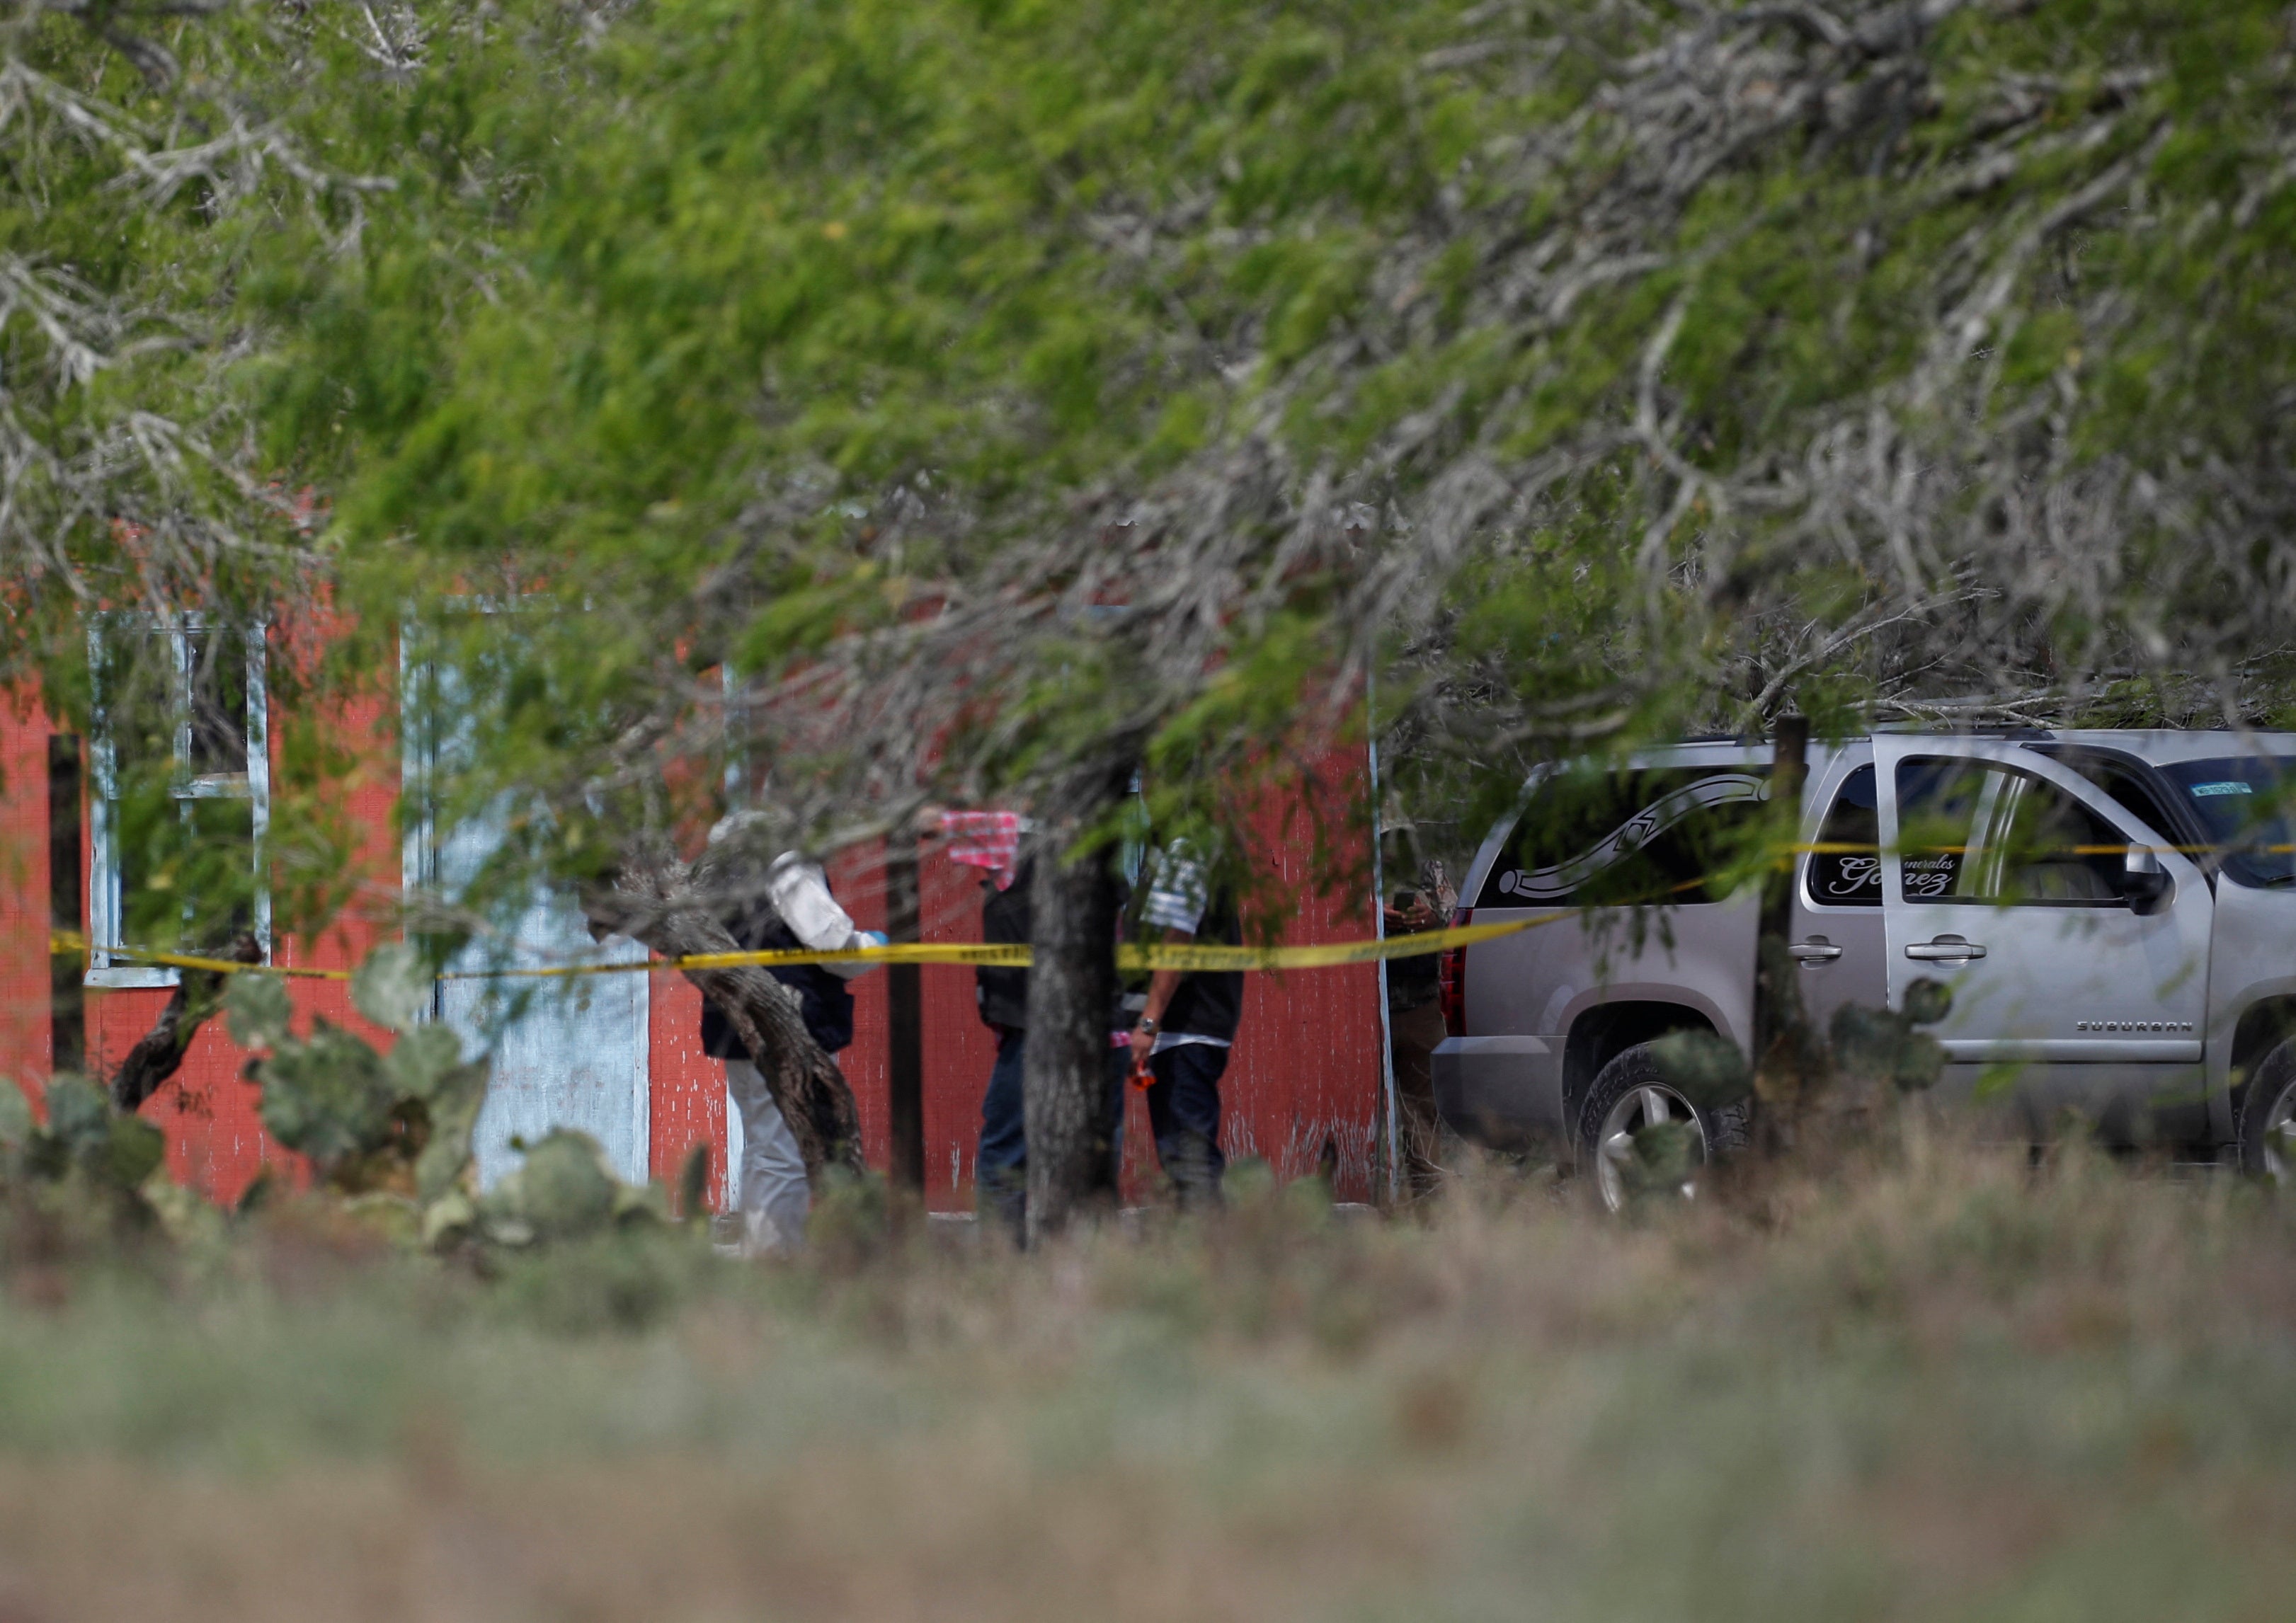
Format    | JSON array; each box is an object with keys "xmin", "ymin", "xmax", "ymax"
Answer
[{"xmin": 1435, "ymin": 733, "xmax": 2296, "ymax": 1200}]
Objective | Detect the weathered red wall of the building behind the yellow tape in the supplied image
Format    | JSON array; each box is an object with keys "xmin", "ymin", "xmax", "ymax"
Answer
[{"xmin": 0, "ymin": 679, "xmax": 1380, "ymax": 1210}]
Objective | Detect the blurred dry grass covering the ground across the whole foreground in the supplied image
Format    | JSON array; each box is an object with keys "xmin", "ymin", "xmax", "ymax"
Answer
[{"xmin": 0, "ymin": 1134, "xmax": 2296, "ymax": 1623}]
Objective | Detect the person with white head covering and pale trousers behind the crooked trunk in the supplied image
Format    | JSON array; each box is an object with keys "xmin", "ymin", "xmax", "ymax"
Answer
[{"xmin": 702, "ymin": 820, "xmax": 884, "ymax": 1256}]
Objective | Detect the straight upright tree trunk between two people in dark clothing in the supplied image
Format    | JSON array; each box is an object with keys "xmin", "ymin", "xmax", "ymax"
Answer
[{"xmin": 1022, "ymin": 774, "xmax": 1125, "ymax": 1244}]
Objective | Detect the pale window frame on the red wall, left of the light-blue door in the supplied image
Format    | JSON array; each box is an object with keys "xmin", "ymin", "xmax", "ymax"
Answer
[{"xmin": 87, "ymin": 613, "xmax": 271, "ymax": 990}]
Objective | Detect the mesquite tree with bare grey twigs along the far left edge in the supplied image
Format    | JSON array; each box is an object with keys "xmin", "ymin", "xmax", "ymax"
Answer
[{"xmin": 0, "ymin": 0, "xmax": 390, "ymax": 1092}]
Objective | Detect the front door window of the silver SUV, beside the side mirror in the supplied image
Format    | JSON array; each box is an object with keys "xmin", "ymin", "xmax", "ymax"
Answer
[{"xmin": 1897, "ymin": 757, "xmax": 2128, "ymax": 907}]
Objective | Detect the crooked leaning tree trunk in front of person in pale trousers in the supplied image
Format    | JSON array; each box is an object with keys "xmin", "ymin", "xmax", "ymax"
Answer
[{"xmin": 583, "ymin": 851, "xmax": 866, "ymax": 1196}]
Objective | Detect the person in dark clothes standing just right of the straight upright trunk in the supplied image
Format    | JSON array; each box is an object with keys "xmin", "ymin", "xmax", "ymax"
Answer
[{"xmin": 1132, "ymin": 842, "xmax": 1245, "ymax": 1210}]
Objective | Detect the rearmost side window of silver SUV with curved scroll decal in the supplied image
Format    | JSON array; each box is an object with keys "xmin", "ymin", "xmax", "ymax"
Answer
[{"xmin": 1474, "ymin": 767, "xmax": 1770, "ymax": 907}]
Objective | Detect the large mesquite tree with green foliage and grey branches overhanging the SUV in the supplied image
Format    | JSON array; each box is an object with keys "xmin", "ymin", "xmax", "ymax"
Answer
[{"xmin": 13, "ymin": 0, "xmax": 2296, "ymax": 1215}]
